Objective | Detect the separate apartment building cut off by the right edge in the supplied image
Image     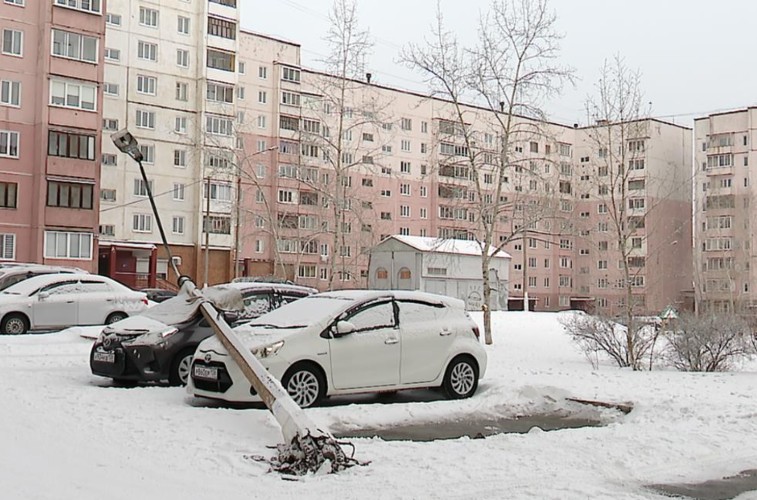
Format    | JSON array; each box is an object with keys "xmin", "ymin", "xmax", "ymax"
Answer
[{"xmin": 694, "ymin": 107, "xmax": 757, "ymax": 316}]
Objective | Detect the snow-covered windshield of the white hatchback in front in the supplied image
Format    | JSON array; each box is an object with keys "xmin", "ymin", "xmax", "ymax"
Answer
[{"xmin": 248, "ymin": 295, "xmax": 355, "ymax": 328}]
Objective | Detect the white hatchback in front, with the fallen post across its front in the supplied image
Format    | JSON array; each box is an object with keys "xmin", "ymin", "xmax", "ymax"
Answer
[{"xmin": 188, "ymin": 290, "xmax": 486, "ymax": 408}]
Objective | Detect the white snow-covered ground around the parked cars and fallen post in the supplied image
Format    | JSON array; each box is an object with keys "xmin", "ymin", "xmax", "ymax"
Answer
[{"xmin": 0, "ymin": 312, "xmax": 757, "ymax": 500}]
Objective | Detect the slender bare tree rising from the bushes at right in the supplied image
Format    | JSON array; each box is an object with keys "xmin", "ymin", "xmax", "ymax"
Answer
[{"xmin": 581, "ymin": 56, "xmax": 690, "ymax": 370}]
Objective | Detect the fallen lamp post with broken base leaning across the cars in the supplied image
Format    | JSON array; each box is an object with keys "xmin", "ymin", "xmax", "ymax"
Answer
[{"xmin": 110, "ymin": 129, "xmax": 365, "ymax": 475}]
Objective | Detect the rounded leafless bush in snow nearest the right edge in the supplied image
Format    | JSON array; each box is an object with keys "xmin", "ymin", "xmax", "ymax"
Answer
[{"xmin": 664, "ymin": 314, "xmax": 755, "ymax": 372}]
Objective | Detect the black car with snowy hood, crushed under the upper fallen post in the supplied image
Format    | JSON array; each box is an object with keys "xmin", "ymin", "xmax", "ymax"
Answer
[{"xmin": 90, "ymin": 283, "xmax": 317, "ymax": 385}]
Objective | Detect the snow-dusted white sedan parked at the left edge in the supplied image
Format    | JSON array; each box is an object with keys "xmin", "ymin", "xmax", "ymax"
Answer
[{"xmin": 0, "ymin": 273, "xmax": 147, "ymax": 334}]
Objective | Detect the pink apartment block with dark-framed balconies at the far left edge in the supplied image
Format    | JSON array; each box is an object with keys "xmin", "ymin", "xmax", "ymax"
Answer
[{"xmin": 0, "ymin": 0, "xmax": 106, "ymax": 271}]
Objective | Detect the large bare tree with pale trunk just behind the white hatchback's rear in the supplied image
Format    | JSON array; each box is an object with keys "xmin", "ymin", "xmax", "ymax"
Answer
[{"xmin": 402, "ymin": 0, "xmax": 571, "ymax": 344}]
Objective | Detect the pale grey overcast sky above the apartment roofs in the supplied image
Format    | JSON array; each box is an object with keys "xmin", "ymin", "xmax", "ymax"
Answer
[{"xmin": 240, "ymin": 0, "xmax": 757, "ymax": 125}]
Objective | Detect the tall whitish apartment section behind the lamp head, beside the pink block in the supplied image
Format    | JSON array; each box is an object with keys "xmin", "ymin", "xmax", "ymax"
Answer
[{"xmin": 99, "ymin": 0, "xmax": 239, "ymax": 286}]
